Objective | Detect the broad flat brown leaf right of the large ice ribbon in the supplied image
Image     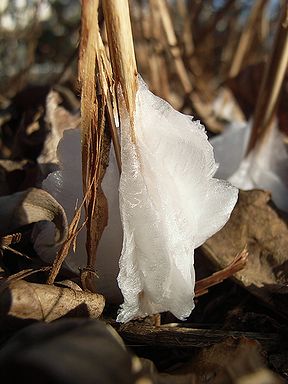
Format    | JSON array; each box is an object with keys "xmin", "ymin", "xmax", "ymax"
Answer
[{"xmin": 200, "ymin": 190, "xmax": 288, "ymax": 317}]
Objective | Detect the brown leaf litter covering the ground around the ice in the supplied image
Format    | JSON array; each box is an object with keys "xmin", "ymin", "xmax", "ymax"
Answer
[{"xmin": 0, "ymin": 0, "xmax": 287, "ymax": 384}]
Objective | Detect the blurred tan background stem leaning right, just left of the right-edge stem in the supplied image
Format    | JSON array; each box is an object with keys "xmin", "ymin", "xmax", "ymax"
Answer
[{"xmin": 229, "ymin": 0, "xmax": 267, "ymax": 77}]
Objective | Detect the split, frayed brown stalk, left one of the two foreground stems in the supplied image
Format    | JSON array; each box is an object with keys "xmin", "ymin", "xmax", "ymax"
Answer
[{"xmin": 77, "ymin": 0, "xmax": 117, "ymax": 291}]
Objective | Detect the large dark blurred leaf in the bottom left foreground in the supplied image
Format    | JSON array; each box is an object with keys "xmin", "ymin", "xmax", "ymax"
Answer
[{"xmin": 0, "ymin": 319, "xmax": 145, "ymax": 384}]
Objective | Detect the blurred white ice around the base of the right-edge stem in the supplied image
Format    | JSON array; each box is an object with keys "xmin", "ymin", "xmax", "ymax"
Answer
[{"xmin": 211, "ymin": 121, "xmax": 288, "ymax": 212}]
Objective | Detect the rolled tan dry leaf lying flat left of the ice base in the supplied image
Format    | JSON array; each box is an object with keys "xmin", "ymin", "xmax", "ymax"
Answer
[{"xmin": 0, "ymin": 279, "xmax": 105, "ymax": 324}]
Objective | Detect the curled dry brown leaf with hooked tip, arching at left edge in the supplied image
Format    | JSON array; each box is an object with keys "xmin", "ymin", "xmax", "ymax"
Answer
[{"xmin": 0, "ymin": 188, "xmax": 67, "ymax": 244}]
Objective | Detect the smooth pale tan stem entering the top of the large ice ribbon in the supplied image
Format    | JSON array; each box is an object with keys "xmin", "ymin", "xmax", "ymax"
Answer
[{"xmin": 102, "ymin": 0, "xmax": 138, "ymax": 136}]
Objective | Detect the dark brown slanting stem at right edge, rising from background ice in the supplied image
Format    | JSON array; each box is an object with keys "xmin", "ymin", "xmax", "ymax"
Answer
[{"xmin": 246, "ymin": 0, "xmax": 288, "ymax": 155}]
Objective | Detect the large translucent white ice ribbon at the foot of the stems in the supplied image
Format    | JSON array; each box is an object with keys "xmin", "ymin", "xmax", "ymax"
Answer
[{"xmin": 33, "ymin": 80, "xmax": 238, "ymax": 322}]
